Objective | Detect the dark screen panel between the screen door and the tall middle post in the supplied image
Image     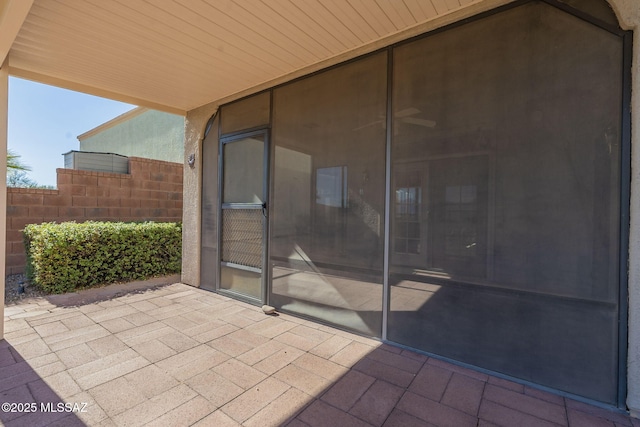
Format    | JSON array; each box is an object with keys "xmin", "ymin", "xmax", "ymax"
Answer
[{"xmin": 270, "ymin": 54, "xmax": 386, "ymax": 336}]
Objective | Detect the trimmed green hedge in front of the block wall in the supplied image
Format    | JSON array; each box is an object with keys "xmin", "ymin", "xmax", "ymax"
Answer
[{"xmin": 24, "ymin": 221, "xmax": 182, "ymax": 294}]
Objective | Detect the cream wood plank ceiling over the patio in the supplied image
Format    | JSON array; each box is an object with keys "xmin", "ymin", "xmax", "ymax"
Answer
[{"xmin": 0, "ymin": 0, "xmax": 477, "ymax": 113}]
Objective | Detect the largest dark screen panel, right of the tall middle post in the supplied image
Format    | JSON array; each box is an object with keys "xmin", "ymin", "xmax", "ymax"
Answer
[{"xmin": 388, "ymin": 2, "xmax": 623, "ymax": 403}]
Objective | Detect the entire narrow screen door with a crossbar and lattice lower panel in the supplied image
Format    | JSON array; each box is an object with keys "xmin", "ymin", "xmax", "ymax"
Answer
[{"xmin": 219, "ymin": 132, "xmax": 267, "ymax": 302}]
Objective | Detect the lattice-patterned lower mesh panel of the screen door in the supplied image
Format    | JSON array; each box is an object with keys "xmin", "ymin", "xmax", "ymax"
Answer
[{"xmin": 222, "ymin": 209, "xmax": 262, "ymax": 268}]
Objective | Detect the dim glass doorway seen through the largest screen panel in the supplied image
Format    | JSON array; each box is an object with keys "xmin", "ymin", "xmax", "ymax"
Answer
[{"xmin": 392, "ymin": 153, "xmax": 489, "ymax": 280}]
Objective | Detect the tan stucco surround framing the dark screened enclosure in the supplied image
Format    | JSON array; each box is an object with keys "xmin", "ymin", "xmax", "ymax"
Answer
[{"xmin": 182, "ymin": 0, "xmax": 640, "ymax": 417}]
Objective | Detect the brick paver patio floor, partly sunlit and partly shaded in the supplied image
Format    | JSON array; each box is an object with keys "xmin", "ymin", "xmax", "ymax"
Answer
[{"xmin": 0, "ymin": 283, "xmax": 640, "ymax": 427}]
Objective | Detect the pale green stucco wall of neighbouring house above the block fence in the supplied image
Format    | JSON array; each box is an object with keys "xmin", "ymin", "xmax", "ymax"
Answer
[{"xmin": 78, "ymin": 108, "xmax": 184, "ymax": 163}]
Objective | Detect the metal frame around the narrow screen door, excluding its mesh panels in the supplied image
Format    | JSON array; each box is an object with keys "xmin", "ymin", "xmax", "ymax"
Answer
[{"xmin": 215, "ymin": 127, "xmax": 271, "ymax": 305}]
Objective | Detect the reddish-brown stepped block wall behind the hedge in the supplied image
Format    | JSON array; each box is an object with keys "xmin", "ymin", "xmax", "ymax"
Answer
[{"xmin": 5, "ymin": 157, "xmax": 183, "ymax": 275}]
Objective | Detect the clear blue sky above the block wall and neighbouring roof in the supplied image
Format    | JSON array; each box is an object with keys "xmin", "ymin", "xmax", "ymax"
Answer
[{"xmin": 8, "ymin": 77, "xmax": 135, "ymax": 185}]
